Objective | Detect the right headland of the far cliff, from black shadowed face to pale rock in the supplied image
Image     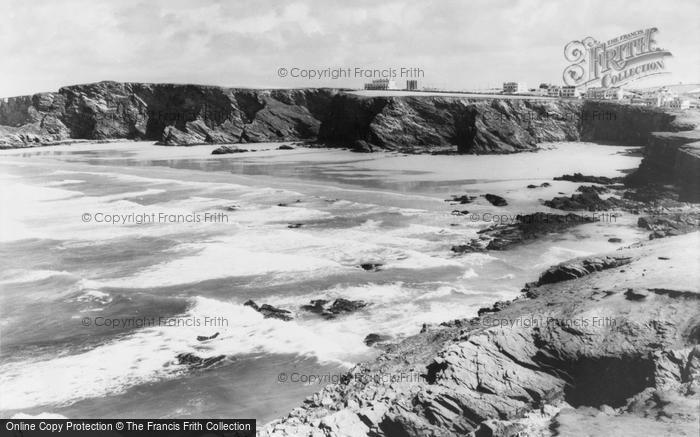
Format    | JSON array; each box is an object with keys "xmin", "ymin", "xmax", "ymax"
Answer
[{"xmin": 319, "ymin": 94, "xmax": 580, "ymax": 153}]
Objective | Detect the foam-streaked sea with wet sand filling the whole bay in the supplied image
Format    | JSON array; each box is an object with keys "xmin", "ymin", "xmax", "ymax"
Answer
[{"xmin": 0, "ymin": 142, "xmax": 643, "ymax": 423}]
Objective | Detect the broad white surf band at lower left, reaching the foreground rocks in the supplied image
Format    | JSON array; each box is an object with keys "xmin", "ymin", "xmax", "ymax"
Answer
[{"xmin": 0, "ymin": 297, "xmax": 368, "ymax": 410}]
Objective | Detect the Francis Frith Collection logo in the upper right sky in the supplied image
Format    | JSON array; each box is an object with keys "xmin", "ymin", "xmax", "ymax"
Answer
[{"xmin": 564, "ymin": 27, "xmax": 671, "ymax": 88}]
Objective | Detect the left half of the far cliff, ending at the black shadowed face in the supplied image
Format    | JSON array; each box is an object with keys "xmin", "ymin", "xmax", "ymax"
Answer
[{"xmin": 0, "ymin": 82, "xmax": 337, "ymax": 147}]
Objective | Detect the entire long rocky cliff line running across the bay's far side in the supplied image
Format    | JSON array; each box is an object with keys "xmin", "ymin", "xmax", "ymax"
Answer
[{"xmin": 0, "ymin": 82, "xmax": 700, "ymax": 196}]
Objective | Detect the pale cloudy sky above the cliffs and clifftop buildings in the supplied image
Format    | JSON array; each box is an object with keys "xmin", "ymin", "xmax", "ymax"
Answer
[{"xmin": 0, "ymin": 0, "xmax": 700, "ymax": 97}]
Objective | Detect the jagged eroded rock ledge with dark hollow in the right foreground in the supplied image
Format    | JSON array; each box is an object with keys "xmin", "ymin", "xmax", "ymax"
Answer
[{"xmin": 262, "ymin": 232, "xmax": 700, "ymax": 436}]
